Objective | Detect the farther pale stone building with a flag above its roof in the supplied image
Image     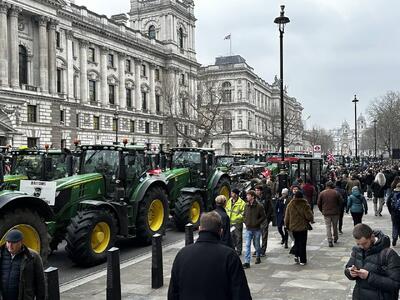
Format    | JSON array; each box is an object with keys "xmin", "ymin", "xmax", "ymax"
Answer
[{"xmin": 199, "ymin": 55, "xmax": 304, "ymax": 154}]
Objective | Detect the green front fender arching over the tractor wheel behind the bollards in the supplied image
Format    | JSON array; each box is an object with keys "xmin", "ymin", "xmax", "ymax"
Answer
[{"xmin": 78, "ymin": 200, "xmax": 128, "ymax": 236}]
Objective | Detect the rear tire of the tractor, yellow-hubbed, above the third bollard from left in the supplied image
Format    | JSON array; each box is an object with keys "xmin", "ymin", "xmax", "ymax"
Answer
[{"xmin": 136, "ymin": 187, "xmax": 169, "ymax": 245}]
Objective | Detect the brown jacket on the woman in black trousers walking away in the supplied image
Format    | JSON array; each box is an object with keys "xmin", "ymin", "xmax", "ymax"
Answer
[{"xmin": 285, "ymin": 198, "xmax": 314, "ymax": 231}]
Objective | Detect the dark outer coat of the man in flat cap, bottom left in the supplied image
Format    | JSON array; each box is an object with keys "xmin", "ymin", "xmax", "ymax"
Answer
[{"xmin": 0, "ymin": 246, "xmax": 46, "ymax": 300}]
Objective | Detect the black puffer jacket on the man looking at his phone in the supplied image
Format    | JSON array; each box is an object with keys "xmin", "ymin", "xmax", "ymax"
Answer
[{"xmin": 344, "ymin": 231, "xmax": 400, "ymax": 300}]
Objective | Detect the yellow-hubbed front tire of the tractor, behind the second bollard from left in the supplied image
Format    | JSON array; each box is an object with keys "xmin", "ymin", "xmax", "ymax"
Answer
[{"xmin": 65, "ymin": 210, "xmax": 116, "ymax": 267}]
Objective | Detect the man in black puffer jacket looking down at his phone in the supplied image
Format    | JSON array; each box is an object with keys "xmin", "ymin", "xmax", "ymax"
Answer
[{"xmin": 344, "ymin": 224, "xmax": 400, "ymax": 300}]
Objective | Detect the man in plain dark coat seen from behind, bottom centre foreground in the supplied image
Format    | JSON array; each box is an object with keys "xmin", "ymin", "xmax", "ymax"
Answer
[{"xmin": 168, "ymin": 212, "xmax": 252, "ymax": 300}]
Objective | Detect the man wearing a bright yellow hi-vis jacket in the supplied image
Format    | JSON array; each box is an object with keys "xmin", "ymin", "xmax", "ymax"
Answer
[{"xmin": 225, "ymin": 189, "xmax": 246, "ymax": 255}]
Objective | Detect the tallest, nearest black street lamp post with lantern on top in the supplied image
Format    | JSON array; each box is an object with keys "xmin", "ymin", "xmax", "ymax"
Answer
[{"xmin": 274, "ymin": 5, "xmax": 290, "ymax": 161}]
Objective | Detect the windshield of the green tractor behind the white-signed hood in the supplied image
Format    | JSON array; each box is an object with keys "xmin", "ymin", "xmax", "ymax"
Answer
[{"xmin": 80, "ymin": 149, "xmax": 119, "ymax": 175}]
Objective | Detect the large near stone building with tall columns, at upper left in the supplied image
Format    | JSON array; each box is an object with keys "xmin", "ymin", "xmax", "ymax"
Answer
[{"xmin": 0, "ymin": 0, "xmax": 199, "ymax": 147}]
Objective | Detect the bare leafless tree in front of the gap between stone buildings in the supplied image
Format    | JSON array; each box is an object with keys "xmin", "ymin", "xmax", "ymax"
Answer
[{"xmin": 164, "ymin": 75, "xmax": 227, "ymax": 147}]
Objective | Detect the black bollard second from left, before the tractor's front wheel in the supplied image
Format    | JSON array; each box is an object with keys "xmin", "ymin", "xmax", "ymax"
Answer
[{"xmin": 106, "ymin": 247, "xmax": 121, "ymax": 300}]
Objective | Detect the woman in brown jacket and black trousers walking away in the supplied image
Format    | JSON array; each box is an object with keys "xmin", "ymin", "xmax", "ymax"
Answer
[{"xmin": 285, "ymin": 191, "xmax": 314, "ymax": 266}]
